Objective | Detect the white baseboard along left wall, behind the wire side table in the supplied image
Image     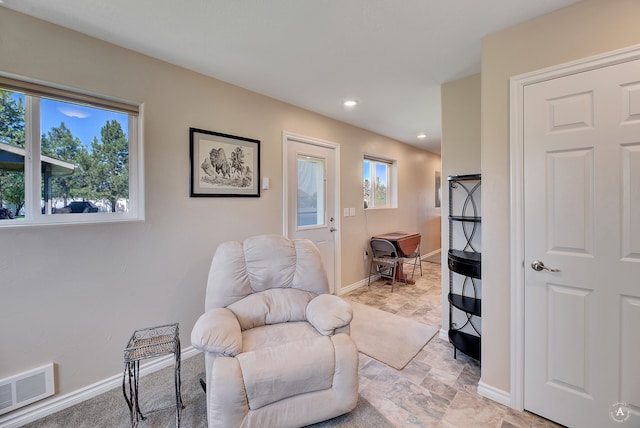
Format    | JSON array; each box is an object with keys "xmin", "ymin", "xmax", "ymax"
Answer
[{"xmin": 0, "ymin": 346, "xmax": 200, "ymax": 428}]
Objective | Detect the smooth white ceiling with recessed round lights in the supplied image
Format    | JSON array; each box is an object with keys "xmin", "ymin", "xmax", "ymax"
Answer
[{"xmin": 0, "ymin": 0, "xmax": 578, "ymax": 153}]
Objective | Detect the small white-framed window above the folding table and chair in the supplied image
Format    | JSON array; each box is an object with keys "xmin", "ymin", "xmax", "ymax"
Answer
[{"xmin": 362, "ymin": 155, "xmax": 397, "ymax": 208}]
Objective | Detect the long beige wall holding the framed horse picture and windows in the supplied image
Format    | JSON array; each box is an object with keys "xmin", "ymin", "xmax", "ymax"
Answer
[{"xmin": 0, "ymin": 7, "xmax": 440, "ymax": 404}]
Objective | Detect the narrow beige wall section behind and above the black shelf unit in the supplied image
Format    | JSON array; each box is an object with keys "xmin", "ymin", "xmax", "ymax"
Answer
[{"xmin": 441, "ymin": 74, "xmax": 484, "ymax": 330}]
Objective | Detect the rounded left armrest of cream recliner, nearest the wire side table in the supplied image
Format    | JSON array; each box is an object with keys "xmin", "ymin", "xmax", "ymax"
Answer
[{"xmin": 191, "ymin": 308, "xmax": 242, "ymax": 357}]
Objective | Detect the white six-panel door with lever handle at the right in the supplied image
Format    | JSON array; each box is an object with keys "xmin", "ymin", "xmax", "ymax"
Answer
[{"xmin": 523, "ymin": 60, "xmax": 640, "ymax": 427}]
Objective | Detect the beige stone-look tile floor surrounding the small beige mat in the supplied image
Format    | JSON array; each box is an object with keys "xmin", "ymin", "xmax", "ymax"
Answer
[{"xmin": 342, "ymin": 262, "xmax": 559, "ymax": 428}]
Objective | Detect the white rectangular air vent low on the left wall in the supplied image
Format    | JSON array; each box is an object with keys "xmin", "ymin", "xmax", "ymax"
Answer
[{"xmin": 0, "ymin": 363, "xmax": 54, "ymax": 415}]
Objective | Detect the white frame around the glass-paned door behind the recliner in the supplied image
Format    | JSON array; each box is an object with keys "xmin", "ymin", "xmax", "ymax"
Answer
[{"xmin": 282, "ymin": 131, "xmax": 342, "ymax": 294}]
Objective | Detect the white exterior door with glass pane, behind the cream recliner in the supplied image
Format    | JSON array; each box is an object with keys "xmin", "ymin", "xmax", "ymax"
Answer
[{"xmin": 284, "ymin": 133, "xmax": 340, "ymax": 294}]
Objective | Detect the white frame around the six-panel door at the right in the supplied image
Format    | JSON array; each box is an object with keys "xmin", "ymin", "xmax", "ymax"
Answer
[{"xmin": 504, "ymin": 45, "xmax": 640, "ymax": 410}]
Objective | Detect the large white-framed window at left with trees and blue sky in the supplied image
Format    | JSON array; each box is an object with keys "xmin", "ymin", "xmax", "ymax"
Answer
[{"xmin": 0, "ymin": 76, "xmax": 142, "ymax": 227}]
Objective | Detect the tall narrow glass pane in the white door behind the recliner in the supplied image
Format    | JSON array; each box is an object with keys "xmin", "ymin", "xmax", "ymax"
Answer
[{"xmin": 297, "ymin": 155, "xmax": 325, "ymax": 227}]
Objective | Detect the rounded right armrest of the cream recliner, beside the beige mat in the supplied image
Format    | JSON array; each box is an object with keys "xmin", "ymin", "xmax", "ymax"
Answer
[{"xmin": 306, "ymin": 294, "xmax": 353, "ymax": 336}]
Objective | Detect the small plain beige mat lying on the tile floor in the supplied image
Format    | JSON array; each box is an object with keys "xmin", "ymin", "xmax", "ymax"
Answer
[{"xmin": 350, "ymin": 302, "xmax": 438, "ymax": 370}]
